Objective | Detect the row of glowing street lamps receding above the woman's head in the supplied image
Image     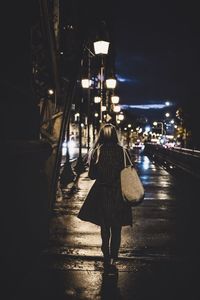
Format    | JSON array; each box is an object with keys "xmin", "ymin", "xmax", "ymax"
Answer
[{"xmin": 81, "ymin": 29, "xmax": 120, "ymax": 144}]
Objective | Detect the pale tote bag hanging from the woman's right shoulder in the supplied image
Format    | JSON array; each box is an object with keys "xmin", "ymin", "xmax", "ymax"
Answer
[{"xmin": 120, "ymin": 148, "xmax": 144, "ymax": 206}]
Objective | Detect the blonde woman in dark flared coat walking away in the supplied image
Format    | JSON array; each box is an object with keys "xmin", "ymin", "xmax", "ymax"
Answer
[{"xmin": 78, "ymin": 124, "xmax": 132, "ymax": 268}]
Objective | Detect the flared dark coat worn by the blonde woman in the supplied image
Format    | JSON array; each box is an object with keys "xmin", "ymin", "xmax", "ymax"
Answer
[{"xmin": 78, "ymin": 143, "xmax": 132, "ymax": 226}]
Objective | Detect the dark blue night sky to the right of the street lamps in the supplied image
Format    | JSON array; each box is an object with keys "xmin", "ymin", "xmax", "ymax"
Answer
[{"xmin": 75, "ymin": 0, "xmax": 200, "ymax": 130}]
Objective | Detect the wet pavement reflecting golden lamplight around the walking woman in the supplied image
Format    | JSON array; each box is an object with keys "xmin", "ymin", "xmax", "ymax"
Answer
[{"xmin": 12, "ymin": 156, "xmax": 200, "ymax": 300}]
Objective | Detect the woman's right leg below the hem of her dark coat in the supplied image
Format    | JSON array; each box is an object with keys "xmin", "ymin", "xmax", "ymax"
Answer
[{"xmin": 110, "ymin": 225, "xmax": 122, "ymax": 259}]
